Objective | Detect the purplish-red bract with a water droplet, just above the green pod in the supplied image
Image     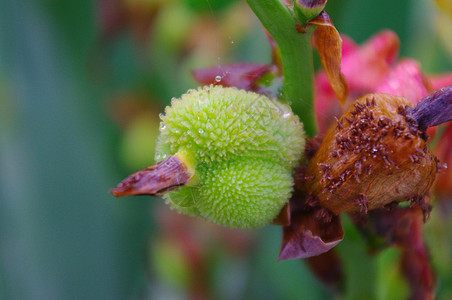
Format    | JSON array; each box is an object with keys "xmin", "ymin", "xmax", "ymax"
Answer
[{"xmin": 192, "ymin": 63, "xmax": 272, "ymax": 91}]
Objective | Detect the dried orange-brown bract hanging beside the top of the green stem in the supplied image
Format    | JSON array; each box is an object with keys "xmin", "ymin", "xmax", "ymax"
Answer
[{"xmin": 309, "ymin": 11, "xmax": 348, "ymax": 104}]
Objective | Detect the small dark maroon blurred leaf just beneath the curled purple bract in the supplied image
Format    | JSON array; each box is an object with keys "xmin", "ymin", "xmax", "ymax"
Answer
[{"xmin": 305, "ymin": 249, "xmax": 345, "ymax": 292}]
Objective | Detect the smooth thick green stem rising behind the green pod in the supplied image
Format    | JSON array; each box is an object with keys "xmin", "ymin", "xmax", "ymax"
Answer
[{"xmin": 247, "ymin": 0, "xmax": 317, "ymax": 136}]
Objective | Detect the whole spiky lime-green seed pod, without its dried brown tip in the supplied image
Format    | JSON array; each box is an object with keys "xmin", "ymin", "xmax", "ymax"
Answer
[{"xmin": 156, "ymin": 86, "xmax": 305, "ymax": 228}]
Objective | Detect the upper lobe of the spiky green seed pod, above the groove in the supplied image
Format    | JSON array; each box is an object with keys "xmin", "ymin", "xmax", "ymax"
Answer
[{"xmin": 156, "ymin": 86, "xmax": 304, "ymax": 167}]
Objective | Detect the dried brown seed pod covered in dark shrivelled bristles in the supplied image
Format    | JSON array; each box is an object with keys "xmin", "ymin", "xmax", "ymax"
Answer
[{"xmin": 304, "ymin": 94, "xmax": 437, "ymax": 214}]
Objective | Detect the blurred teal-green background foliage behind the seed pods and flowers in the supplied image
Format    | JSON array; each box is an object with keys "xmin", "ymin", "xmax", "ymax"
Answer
[{"xmin": 0, "ymin": 0, "xmax": 452, "ymax": 299}]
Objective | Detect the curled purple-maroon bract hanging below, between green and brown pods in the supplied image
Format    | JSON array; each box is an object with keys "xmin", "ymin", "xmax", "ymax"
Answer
[{"xmin": 278, "ymin": 193, "xmax": 344, "ymax": 260}]
